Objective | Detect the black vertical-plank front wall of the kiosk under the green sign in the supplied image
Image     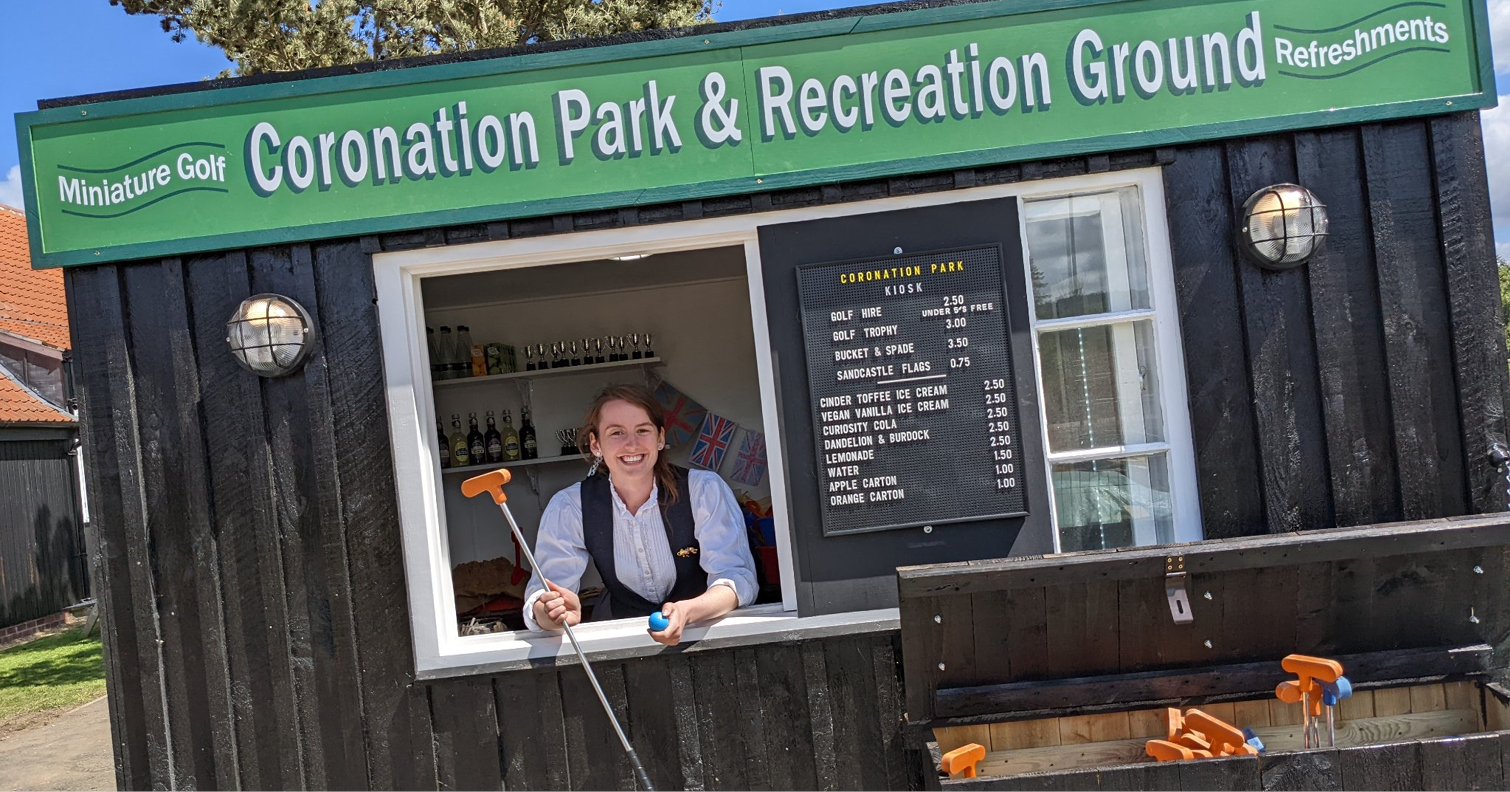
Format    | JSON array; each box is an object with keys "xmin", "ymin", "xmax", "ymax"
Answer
[{"xmin": 66, "ymin": 113, "xmax": 1507, "ymax": 789}]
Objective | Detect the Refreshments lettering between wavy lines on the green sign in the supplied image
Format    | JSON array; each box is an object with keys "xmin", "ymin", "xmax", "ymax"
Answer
[{"xmin": 1274, "ymin": 2, "xmax": 1453, "ymax": 80}]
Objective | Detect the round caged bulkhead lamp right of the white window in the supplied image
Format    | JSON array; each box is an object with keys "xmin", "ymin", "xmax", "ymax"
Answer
[{"xmin": 1238, "ymin": 184, "xmax": 1327, "ymax": 270}]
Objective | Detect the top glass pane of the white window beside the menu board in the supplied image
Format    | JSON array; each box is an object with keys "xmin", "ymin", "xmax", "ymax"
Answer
[{"xmin": 1027, "ymin": 187, "xmax": 1149, "ymax": 320}]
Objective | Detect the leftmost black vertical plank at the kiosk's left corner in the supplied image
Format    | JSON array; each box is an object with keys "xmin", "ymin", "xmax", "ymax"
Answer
[{"xmin": 65, "ymin": 267, "xmax": 154, "ymax": 789}]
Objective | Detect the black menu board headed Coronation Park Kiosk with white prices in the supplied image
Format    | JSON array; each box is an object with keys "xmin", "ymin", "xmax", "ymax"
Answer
[{"xmin": 797, "ymin": 246, "xmax": 1027, "ymax": 536}]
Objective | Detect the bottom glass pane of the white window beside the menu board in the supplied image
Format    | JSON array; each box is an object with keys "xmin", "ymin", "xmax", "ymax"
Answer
[{"xmin": 1052, "ymin": 454, "xmax": 1175, "ymax": 552}]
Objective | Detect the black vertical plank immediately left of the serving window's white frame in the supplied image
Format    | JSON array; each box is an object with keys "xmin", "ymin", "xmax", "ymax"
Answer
[{"xmin": 309, "ymin": 240, "xmax": 435, "ymax": 789}]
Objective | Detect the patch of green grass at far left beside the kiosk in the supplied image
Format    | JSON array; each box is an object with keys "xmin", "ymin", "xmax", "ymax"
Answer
[{"xmin": 0, "ymin": 628, "xmax": 104, "ymax": 730}]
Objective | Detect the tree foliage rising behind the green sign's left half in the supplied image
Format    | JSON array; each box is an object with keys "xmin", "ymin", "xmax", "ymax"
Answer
[{"xmin": 110, "ymin": 0, "xmax": 713, "ymax": 77}]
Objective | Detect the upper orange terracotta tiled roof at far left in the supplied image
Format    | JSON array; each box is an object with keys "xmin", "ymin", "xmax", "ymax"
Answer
[{"xmin": 0, "ymin": 205, "xmax": 69, "ymax": 348}]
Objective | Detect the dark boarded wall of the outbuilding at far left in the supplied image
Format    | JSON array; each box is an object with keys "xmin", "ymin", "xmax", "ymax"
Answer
[{"xmin": 0, "ymin": 427, "xmax": 89, "ymax": 628}]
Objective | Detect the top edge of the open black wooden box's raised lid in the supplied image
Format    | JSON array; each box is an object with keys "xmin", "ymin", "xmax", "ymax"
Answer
[{"xmin": 897, "ymin": 514, "xmax": 1510, "ymax": 602}]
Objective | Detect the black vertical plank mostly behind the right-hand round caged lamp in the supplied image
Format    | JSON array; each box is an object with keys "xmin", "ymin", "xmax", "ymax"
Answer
[{"xmin": 1226, "ymin": 136, "xmax": 1335, "ymax": 534}]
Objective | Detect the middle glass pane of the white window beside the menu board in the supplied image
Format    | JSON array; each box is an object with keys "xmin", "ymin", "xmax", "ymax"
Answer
[{"xmin": 1039, "ymin": 320, "xmax": 1164, "ymax": 451}]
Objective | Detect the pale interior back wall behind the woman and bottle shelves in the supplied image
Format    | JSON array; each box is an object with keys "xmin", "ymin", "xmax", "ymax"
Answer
[{"xmin": 426, "ymin": 264, "xmax": 769, "ymax": 573}]
